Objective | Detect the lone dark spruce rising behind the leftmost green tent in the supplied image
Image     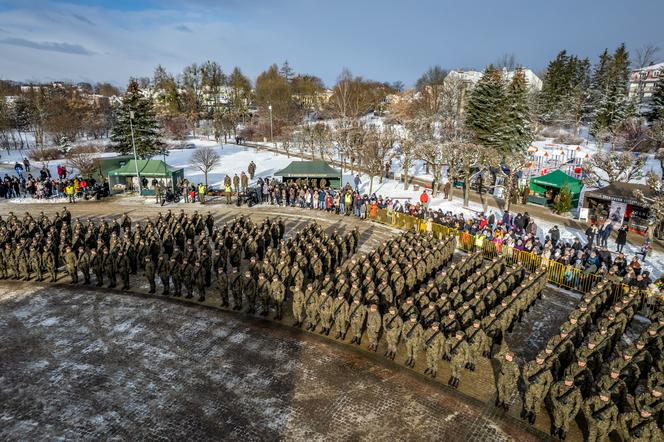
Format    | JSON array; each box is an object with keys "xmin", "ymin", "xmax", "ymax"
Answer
[{"xmin": 111, "ymin": 80, "xmax": 163, "ymax": 158}]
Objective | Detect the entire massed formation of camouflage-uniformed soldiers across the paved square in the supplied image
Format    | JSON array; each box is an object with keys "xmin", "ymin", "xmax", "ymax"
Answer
[{"xmin": 0, "ymin": 208, "xmax": 664, "ymax": 440}]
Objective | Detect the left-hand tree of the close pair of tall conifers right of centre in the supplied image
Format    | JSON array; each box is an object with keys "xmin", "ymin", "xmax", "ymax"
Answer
[{"xmin": 465, "ymin": 65, "xmax": 506, "ymax": 150}]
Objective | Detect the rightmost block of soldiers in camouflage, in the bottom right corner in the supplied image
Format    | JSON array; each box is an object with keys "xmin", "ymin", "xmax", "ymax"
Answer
[{"xmin": 516, "ymin": 282, "xmax": 664, "ymax": 441}]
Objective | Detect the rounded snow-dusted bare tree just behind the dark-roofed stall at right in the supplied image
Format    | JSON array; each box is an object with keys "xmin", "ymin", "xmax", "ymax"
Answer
[{"xmin": 584, "ymin": 151, "xmax": 646, "ymax": 187}]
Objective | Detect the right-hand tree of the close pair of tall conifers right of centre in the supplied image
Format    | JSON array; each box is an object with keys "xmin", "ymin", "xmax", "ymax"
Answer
[{"xmin": 504, "ymin": 69, "xmax": 535, "ymax": 154}]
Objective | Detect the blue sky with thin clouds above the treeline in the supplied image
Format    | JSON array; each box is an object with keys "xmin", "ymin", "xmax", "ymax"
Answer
[{"xmin": 0, "ymin": 0, "xmax": 664, "ymax": 86}]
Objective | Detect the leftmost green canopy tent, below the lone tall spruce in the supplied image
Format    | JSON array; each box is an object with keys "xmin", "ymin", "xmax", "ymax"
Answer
[{"xmin": 108, "ymin": 160, "xmax": 184, "ymax": 195}]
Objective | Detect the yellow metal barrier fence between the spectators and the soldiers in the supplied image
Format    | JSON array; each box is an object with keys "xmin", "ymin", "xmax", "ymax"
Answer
[{"xmin": 369, "ymin": 209, "xmax": 658, "ymax": 316}]
